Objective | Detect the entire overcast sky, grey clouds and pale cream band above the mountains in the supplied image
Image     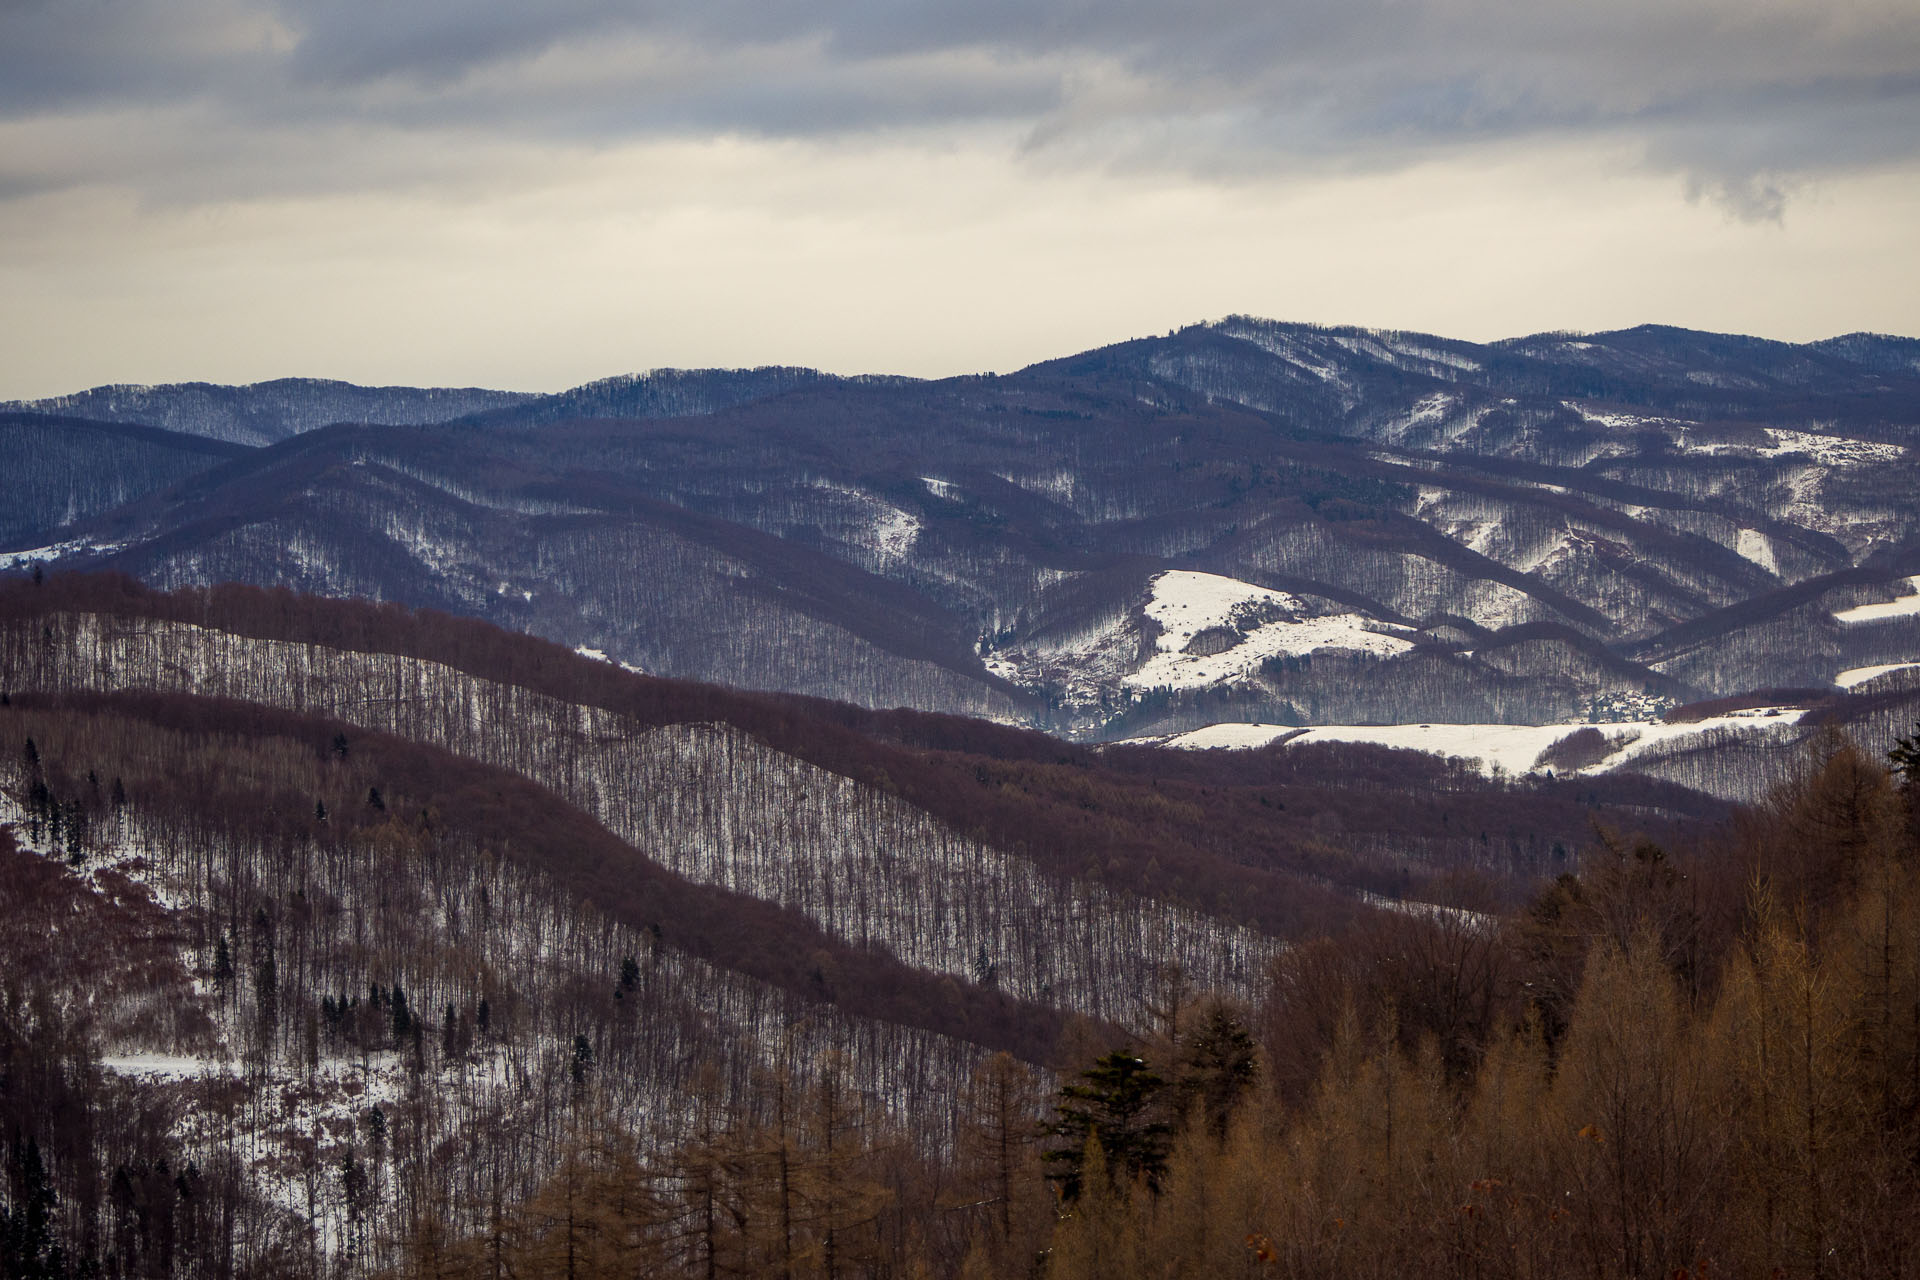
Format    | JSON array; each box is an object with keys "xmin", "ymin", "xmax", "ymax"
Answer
[{"xmin": 0, "ymin": 0, "xmax": 1920, "ymax": 397}]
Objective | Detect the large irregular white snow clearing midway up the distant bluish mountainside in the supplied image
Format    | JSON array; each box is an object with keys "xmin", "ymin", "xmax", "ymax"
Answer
[{"xmin": 1121, "ymin": 570, "xmax": 1413, "ymax": 689}]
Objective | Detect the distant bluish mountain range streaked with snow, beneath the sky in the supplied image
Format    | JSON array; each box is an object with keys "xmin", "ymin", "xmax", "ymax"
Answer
[{"xmin": 11, "ymin": 317, "xmax": 1920, "ymax": 759}]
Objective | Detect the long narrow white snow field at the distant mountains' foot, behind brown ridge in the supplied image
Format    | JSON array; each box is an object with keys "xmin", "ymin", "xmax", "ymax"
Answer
[{"xmin": 1152, "ymin": 706, "xmax": 1799, "ymax": 773}]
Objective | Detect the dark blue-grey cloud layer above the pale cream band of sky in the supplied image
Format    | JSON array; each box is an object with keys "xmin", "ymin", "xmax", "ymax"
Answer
[{"xmin": 0, "ymin": 0, "xmax": 1920, "ymax": 217}]
